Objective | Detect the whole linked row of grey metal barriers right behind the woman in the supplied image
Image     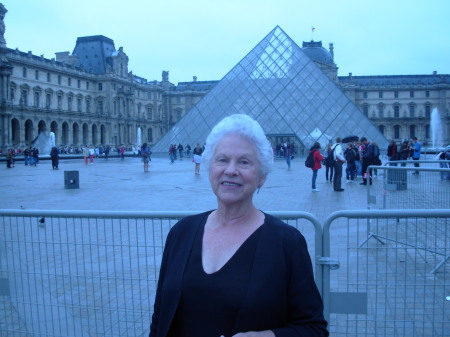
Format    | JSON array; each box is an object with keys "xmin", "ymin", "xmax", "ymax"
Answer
[{"xmin": 0, "ymin": 209, "xmax": 450, "ymax": 337}]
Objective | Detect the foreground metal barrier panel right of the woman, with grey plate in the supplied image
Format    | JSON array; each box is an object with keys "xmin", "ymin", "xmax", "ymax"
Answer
[{"xmin": 322, "ymin": 209, "xmax": 450, "ymax": 337}]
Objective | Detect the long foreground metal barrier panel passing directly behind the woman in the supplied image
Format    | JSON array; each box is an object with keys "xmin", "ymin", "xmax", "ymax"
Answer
[{"xmin": 0, "ymin": 210, "xmax": 326, "ymax": 337}]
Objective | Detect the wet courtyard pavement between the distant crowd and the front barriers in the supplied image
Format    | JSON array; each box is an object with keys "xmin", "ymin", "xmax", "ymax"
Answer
[{"xmin": 0, "ymin": 155, "xmax": 367, "ymax": 221}]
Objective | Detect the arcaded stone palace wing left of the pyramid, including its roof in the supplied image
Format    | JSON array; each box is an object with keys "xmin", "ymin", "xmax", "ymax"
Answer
[{"xmin": 0, "ymin": 27, "xmax": 209, "ymax": 150}]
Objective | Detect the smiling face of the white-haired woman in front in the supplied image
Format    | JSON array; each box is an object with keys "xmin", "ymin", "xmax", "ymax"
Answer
[{"xmin": 209, "ymin": 134, "xmax": 266, "ymax": 204}]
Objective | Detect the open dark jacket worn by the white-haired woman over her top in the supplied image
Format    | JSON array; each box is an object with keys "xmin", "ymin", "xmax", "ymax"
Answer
[{"xmin": 150, "ymin": 212, "xmax": 328, "ymax": 337}]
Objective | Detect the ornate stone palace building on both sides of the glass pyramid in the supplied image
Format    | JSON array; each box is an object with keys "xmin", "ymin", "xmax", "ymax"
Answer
[{"xmin": 0, "ymin": 4, "xmax": 450, "ymax": 153}]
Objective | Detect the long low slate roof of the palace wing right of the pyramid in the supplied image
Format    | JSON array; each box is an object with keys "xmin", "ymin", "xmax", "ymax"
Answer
[{"xmin": 338, "ymin": 74, "xmax": 450, "ymax": 87}]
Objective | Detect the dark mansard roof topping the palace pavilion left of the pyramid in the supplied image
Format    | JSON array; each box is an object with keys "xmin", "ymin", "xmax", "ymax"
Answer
[{"xmin": 72, "ymin": 35, "xmax": 116, "ymax": 74}]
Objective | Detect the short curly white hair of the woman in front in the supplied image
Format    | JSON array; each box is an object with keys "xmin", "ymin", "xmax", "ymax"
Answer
[{"xmin": 203, "ymin": 114, "xmax": 273, "ymax": 175}]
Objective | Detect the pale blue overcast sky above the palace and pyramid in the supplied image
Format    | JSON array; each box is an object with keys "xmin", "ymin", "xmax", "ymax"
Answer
[{"xmin": 0, "ymin": 0, "xmax": 450, "ymax": 84}]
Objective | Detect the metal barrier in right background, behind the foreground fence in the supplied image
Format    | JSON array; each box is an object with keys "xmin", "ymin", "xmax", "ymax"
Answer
[{"xmin": 367, "ymin": 160, "xmax": 450, "ymax": 209}]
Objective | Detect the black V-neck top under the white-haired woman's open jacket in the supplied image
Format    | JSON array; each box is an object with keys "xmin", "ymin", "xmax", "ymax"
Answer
[{"xmin": 167, "ymin": 217, "xmax": 262, "ymax": 337}]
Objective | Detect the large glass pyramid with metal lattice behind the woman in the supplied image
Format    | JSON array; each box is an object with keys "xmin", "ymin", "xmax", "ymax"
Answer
[{"xmin": 153, "ymin": 26, "xmax": 388, "ymax": 152}]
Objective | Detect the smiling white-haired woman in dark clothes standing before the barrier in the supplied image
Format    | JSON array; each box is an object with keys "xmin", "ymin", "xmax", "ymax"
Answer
[{"xmin": 150, "ymin": 114, "xmax": 328, "ymax": 337}]
